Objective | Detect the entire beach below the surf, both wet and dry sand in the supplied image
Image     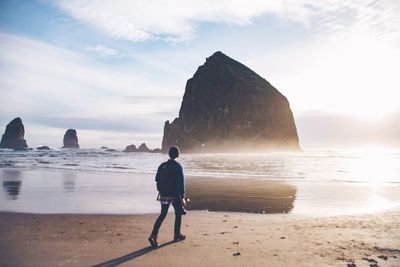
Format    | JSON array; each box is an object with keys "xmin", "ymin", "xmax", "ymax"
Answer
[{"xmin": 0, "ymin": 157, "xmax": 400, "ymax": 267}]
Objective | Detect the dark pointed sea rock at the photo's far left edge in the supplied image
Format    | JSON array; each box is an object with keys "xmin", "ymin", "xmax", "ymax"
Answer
[{"xmin": 0, "ymin": 118, "xmax": 28, "ymax": 150}]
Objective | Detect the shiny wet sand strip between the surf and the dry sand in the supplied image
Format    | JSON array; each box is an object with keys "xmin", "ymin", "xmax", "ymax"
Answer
[{"xmin": 0, "ymin": 169, "xmax": 400, "ymax": 216}]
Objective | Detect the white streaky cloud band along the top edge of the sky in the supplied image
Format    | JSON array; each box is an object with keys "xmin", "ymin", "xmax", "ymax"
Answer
[{"xmin": 53, "ymin": 0, "xmax": 400, "ymax": 41}]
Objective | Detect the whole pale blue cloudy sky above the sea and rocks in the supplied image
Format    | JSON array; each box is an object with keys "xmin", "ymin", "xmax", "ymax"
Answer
[{"xmin": 0, "ymin": 0, "xmax": 400, "ymax": 149}]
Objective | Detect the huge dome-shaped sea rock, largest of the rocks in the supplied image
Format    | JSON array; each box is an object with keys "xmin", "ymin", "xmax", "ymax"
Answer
[{"xmin": 162, "ymin": 52, "xmax": 300, "ymax": 152}]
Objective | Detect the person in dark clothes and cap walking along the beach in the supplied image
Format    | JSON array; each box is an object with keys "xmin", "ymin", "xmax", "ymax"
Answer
[{"xmin": 148, "ymin": 147, "xmax": 186, "ymax": 248}]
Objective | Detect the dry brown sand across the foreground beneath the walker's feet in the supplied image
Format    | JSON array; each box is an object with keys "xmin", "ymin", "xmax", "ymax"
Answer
[{"xmin": 0, "ymin": 209, "xmax": 400, "ymax": 267}]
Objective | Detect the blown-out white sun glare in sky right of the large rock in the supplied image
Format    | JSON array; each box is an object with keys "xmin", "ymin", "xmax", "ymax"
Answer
[{"xmin": 288, "ymin": 36, "xmax": 400, "ymax": 120}]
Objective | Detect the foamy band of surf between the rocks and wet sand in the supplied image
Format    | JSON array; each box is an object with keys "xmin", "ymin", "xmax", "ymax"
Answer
[{"xmin": 0, "ymin": 149, "xmax": 400, "ymax": 183}]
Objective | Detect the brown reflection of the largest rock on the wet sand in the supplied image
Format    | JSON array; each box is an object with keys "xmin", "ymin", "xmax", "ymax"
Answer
[{"xmin": 186, "ymin": 177, "xmax": 297, "ymax": 213}]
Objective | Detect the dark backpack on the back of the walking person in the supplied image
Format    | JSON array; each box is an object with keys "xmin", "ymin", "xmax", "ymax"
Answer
[{"xmin": 156, "ymin": 161, "xmax": 176, "ymax": 197}]
